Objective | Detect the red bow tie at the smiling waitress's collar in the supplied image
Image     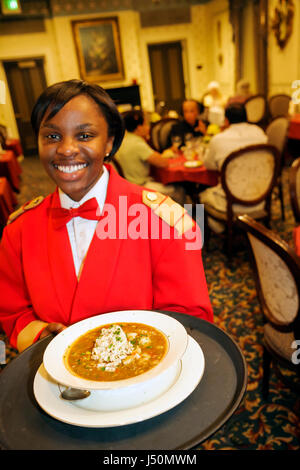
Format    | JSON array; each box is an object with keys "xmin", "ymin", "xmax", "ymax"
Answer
[{"xmin": 51, "ymin": 197, "xmax": 101, "ymax": 229}]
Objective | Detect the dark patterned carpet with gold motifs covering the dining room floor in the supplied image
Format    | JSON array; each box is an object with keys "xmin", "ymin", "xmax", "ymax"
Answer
[{"xmin": 0, "ymin": 158, "xmax": 300, "ymax": 450}]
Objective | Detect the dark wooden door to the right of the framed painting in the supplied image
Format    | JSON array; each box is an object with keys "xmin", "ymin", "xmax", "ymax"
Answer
[{"xmin": 148, "ymin": 41, "xmax": 185, "ymax": 112}]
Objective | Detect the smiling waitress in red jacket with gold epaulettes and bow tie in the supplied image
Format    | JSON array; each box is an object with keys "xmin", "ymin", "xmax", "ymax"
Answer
[{"xmin": 0, "ymin": 80, "xmax": 213, "ymax": 351}]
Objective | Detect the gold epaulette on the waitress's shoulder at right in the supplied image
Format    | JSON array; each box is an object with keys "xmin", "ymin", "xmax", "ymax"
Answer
[{"xmin": 142, "ymin": 190, "xmax": 195, "ymax": 235}]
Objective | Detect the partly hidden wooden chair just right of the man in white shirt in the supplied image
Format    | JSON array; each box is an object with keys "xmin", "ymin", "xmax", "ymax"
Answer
[{"xmin": 266, "ymin": 116, "xmax": 290, "ymax": 220}]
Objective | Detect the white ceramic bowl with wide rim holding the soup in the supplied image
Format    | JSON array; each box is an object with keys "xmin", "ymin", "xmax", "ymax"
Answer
[{"xmin": 43, "ymin": 310, "xmax": 188, "ymax": 411}]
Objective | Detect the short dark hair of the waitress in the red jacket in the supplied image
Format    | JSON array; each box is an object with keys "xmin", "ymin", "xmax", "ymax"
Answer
[{"xmin": 31, "ymin": 79, "xmax": 125, "ymax": 157}]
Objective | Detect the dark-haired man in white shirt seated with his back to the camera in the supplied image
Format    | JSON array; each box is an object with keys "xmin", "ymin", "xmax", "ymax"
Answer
[{"xmin": 200, "ymin": 104, "xmax": 268, "ymax": 233}]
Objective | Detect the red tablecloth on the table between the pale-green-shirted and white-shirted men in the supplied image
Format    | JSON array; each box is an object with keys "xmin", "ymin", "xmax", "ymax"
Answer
[{"xmin": 152, "ymin": 157, "xmax": 219, "ymax": 186}]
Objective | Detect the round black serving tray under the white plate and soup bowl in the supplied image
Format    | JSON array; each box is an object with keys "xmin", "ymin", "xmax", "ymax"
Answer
[{"xmin": 0, "ymin": 312, "xmax": 247, "ymax": 450}]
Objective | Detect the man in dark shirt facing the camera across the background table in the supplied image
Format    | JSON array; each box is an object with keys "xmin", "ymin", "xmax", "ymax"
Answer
[{"xmin": 169, "ymin": 100, "xmax": 206, "ymax": 146}]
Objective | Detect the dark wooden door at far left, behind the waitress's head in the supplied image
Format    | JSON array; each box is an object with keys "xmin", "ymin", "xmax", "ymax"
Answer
[{"xmin": 4, "ymin": 59, "xmax": 46, "ymax": 156}]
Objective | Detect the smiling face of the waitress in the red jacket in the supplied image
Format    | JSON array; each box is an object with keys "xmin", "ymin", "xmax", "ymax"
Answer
[{"xmin": 38, "ymin": 95, "xmax": 113, "ymax": 201}]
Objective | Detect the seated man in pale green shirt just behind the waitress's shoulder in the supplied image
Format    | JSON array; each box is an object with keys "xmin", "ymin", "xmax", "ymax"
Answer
[{"xmin": 116, "ymin": 110, "xmax": 185, "ymax": 205}]
